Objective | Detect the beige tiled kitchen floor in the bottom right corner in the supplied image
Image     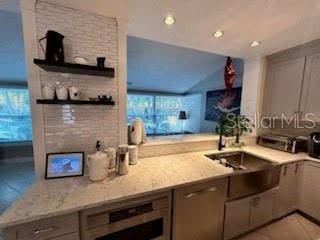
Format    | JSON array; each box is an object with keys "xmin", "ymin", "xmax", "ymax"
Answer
[{"xmin": 237, "ymin": 214, "xmax": 320, "ymax": 240}]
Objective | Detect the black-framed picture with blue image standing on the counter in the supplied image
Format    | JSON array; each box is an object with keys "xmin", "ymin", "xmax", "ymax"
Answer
[{"xmin": 45, "ymin": 152, "xmax": 84, "ymax": 179}]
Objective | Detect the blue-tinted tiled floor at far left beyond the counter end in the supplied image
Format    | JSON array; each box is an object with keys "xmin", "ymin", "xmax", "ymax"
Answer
[{"xmin": 0, "ymin": 163, "xmax": 35, "ymax": 214}]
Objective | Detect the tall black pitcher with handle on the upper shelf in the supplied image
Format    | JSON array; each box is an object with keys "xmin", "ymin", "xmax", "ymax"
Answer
[{"xmin": 39, "ymin": 30, "xmax": 64, "ymax": 62}]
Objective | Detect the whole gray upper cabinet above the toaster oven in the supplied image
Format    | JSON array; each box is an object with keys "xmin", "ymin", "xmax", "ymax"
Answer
[{"xmin": 262, "ymin": 40, "xmax": 320, "ymax": 121}]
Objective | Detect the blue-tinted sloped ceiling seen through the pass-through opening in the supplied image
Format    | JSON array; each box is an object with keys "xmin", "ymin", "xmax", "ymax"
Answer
[{"xmin": 127, "ymin": 37, "xmax": 242, "ymax": 94}]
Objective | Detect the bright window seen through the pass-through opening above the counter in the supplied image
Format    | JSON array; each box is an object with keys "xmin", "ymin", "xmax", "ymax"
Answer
[{"xmin": 127, "ymin": 94, "xmax": 182, "ymax": 135}]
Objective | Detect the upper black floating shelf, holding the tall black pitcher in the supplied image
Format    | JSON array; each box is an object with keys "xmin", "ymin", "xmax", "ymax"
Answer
[{"xmin": 33, "ymin": 59, "xmax": 114, "ymax": 78}]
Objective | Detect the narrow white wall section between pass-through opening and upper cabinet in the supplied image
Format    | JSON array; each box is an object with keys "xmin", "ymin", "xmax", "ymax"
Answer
[{"xmin": 241, "ymin": 57, "xmax": 266, "ymax": 134}]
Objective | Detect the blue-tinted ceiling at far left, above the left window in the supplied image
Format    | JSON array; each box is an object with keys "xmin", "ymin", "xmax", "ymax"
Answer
[{"xmin": 0, "ymin": 10, "xmax": 26, "ymax": 83}]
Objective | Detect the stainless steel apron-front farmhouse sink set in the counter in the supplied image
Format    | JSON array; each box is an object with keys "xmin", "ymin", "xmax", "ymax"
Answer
[{"xmin": 206, "ymin": 152, "xmax": 281, "ymax": 200}]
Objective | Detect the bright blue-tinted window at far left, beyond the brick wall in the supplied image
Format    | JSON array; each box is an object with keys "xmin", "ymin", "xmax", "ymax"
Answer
[{"xmin": 0, "ymin": 88, "xmax": 32, "ymax": 142}]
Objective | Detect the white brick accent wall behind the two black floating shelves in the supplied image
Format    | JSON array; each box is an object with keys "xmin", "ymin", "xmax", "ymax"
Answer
[{"xmin": 36, "ymin": 1, "xmax": 119, "ymax": 153}]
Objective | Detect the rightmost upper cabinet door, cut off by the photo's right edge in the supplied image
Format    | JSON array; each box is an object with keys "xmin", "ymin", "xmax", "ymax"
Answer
[{"xmin": 300, "ymin": 53, "xmax": 320, "ymax": 121}]
